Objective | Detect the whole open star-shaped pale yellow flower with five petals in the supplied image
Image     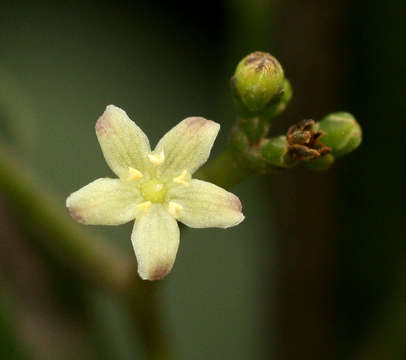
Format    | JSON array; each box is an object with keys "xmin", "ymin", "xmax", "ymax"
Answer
[{"xmin": 66, "ymin": 105, "xmax": 244, "ymax": 280}]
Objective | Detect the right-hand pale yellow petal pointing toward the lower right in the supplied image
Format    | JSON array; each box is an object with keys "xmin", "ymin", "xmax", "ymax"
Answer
[{"xmin": 168, "ymin": 179, "xmax": 244, "ymax": 228}]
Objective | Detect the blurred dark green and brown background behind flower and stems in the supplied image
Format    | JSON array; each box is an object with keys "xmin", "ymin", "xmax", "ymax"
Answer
[{"xmin": 0, "ymin": 0, "xmax": 406, "ymax": 360}]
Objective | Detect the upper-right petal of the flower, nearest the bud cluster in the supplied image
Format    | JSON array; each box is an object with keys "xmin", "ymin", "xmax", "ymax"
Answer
[{"xmin": 154, "ymin": 117, "xmax": 220, "ymax": 176}]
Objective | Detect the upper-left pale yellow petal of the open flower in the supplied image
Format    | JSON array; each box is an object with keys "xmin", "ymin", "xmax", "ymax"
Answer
[{"xmin": 96, "ymin": 105, "xmax": 151, "ymax": 178}]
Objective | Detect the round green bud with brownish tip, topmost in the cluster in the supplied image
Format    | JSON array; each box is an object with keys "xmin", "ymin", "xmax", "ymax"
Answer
[{"xmin": 232, "ymin": 51, "xmax": 284, "ymax": 112}]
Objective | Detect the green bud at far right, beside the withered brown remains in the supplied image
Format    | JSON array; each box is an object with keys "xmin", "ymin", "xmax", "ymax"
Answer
[{"xmin": 316, "ymin": 112, "xmax": 362, "ymax": 157}]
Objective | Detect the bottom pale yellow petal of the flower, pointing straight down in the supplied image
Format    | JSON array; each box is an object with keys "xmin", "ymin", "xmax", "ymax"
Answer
[{"xmin": 131, "ymin": 204, "xmax": 179, "ymax": 280}]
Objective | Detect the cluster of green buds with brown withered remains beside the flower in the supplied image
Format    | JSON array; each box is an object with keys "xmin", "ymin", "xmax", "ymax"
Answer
[{"xmin": 231, "ymin": 51, "xmax": 362, "ymax": 171}]
